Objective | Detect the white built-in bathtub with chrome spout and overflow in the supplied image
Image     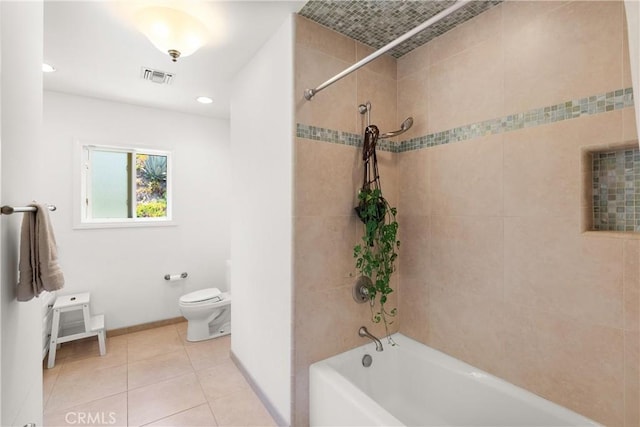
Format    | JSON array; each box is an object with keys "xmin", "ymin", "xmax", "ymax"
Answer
[{"xmin": 309, "ymin": 334, "xmax": 600, "ymax": 427}]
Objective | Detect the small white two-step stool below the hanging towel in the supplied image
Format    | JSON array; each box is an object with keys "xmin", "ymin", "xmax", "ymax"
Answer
[{"xmin": 47, "ymin": 292, "xmax": 106, "ymax": 369}]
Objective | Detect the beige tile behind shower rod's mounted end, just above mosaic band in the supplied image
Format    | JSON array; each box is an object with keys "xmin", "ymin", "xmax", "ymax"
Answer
[{"xmin": 294, "ymin": 45, "xmax": 360, "ymax": 133}]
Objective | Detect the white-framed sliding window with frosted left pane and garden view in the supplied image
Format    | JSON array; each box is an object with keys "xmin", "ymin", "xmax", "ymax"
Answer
[{"xmin": 80, "ymin": 144, "xmax": 171, "ymax": 225}]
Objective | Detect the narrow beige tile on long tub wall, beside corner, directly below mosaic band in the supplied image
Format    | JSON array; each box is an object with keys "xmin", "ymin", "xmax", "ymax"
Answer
[{"xmin": 397, "ymin": 150, "xmax": 433, "ymax": 215}]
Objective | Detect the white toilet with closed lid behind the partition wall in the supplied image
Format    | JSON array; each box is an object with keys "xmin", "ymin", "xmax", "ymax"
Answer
[{"xmin": 179, "ymin": 288, "xmax": 231, "ymax": 341}]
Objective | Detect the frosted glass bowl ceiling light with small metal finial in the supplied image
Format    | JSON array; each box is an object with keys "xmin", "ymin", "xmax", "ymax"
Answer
[{"xmin": 135, "ymin": 7, "xmax": 208, "ymax": 62}]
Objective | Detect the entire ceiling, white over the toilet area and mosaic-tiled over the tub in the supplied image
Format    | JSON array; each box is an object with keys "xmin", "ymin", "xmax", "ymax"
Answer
[{"xmin": 44, "ymin": 0, "xmax": 501, "ymax": 118}]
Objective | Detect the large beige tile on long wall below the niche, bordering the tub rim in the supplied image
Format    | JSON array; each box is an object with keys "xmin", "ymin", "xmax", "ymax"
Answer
[{"xmin": 503, "ymin": 303, "xmax": 624, "ymax": 426}]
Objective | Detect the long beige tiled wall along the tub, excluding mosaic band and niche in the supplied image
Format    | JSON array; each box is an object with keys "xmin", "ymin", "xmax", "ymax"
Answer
[{"xmin": 398, "ymin": 2, "xmax": 640, "ymax": 426}]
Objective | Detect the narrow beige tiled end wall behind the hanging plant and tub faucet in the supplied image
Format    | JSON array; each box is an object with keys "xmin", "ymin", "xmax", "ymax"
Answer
[{"xmin": 292, "ymin": 17, "xmax": 399, "ymax": 426}]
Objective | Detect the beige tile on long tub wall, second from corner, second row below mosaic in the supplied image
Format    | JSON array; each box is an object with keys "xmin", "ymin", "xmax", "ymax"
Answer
[{"xmin": 428, "ymin": 216, "xmax": 504, "ymax": 300}]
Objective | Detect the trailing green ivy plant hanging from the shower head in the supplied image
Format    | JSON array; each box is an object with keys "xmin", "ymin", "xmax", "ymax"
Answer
[{"xmin": 353, "ymin": 187, "xmax": 400, "ymax": 345}]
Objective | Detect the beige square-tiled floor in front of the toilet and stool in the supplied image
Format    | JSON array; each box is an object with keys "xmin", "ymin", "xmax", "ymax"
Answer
[{"xmin": 44, "ymin": 323, "xmax": 276, "ymax": 427}]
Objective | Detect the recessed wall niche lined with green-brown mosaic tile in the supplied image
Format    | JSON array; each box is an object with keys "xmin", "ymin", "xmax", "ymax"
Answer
[{"xmin": 590, "ymin": 147, "xmax": 640, "ymax": 232}]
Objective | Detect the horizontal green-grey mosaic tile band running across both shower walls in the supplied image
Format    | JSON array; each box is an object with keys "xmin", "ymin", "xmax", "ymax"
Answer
[{"xmin": 296, "ymin": 88, "xmax": 633, "ymax": 153}]
